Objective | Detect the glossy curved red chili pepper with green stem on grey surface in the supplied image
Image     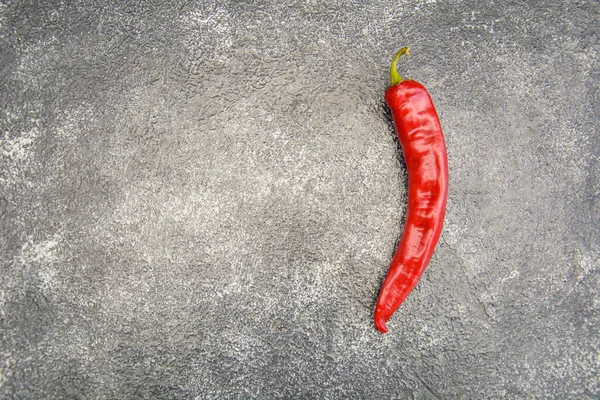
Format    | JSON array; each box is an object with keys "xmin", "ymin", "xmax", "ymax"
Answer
[{"xmin": 375, "ymin": 47, "xmax": 448, "ymax": 333}]
